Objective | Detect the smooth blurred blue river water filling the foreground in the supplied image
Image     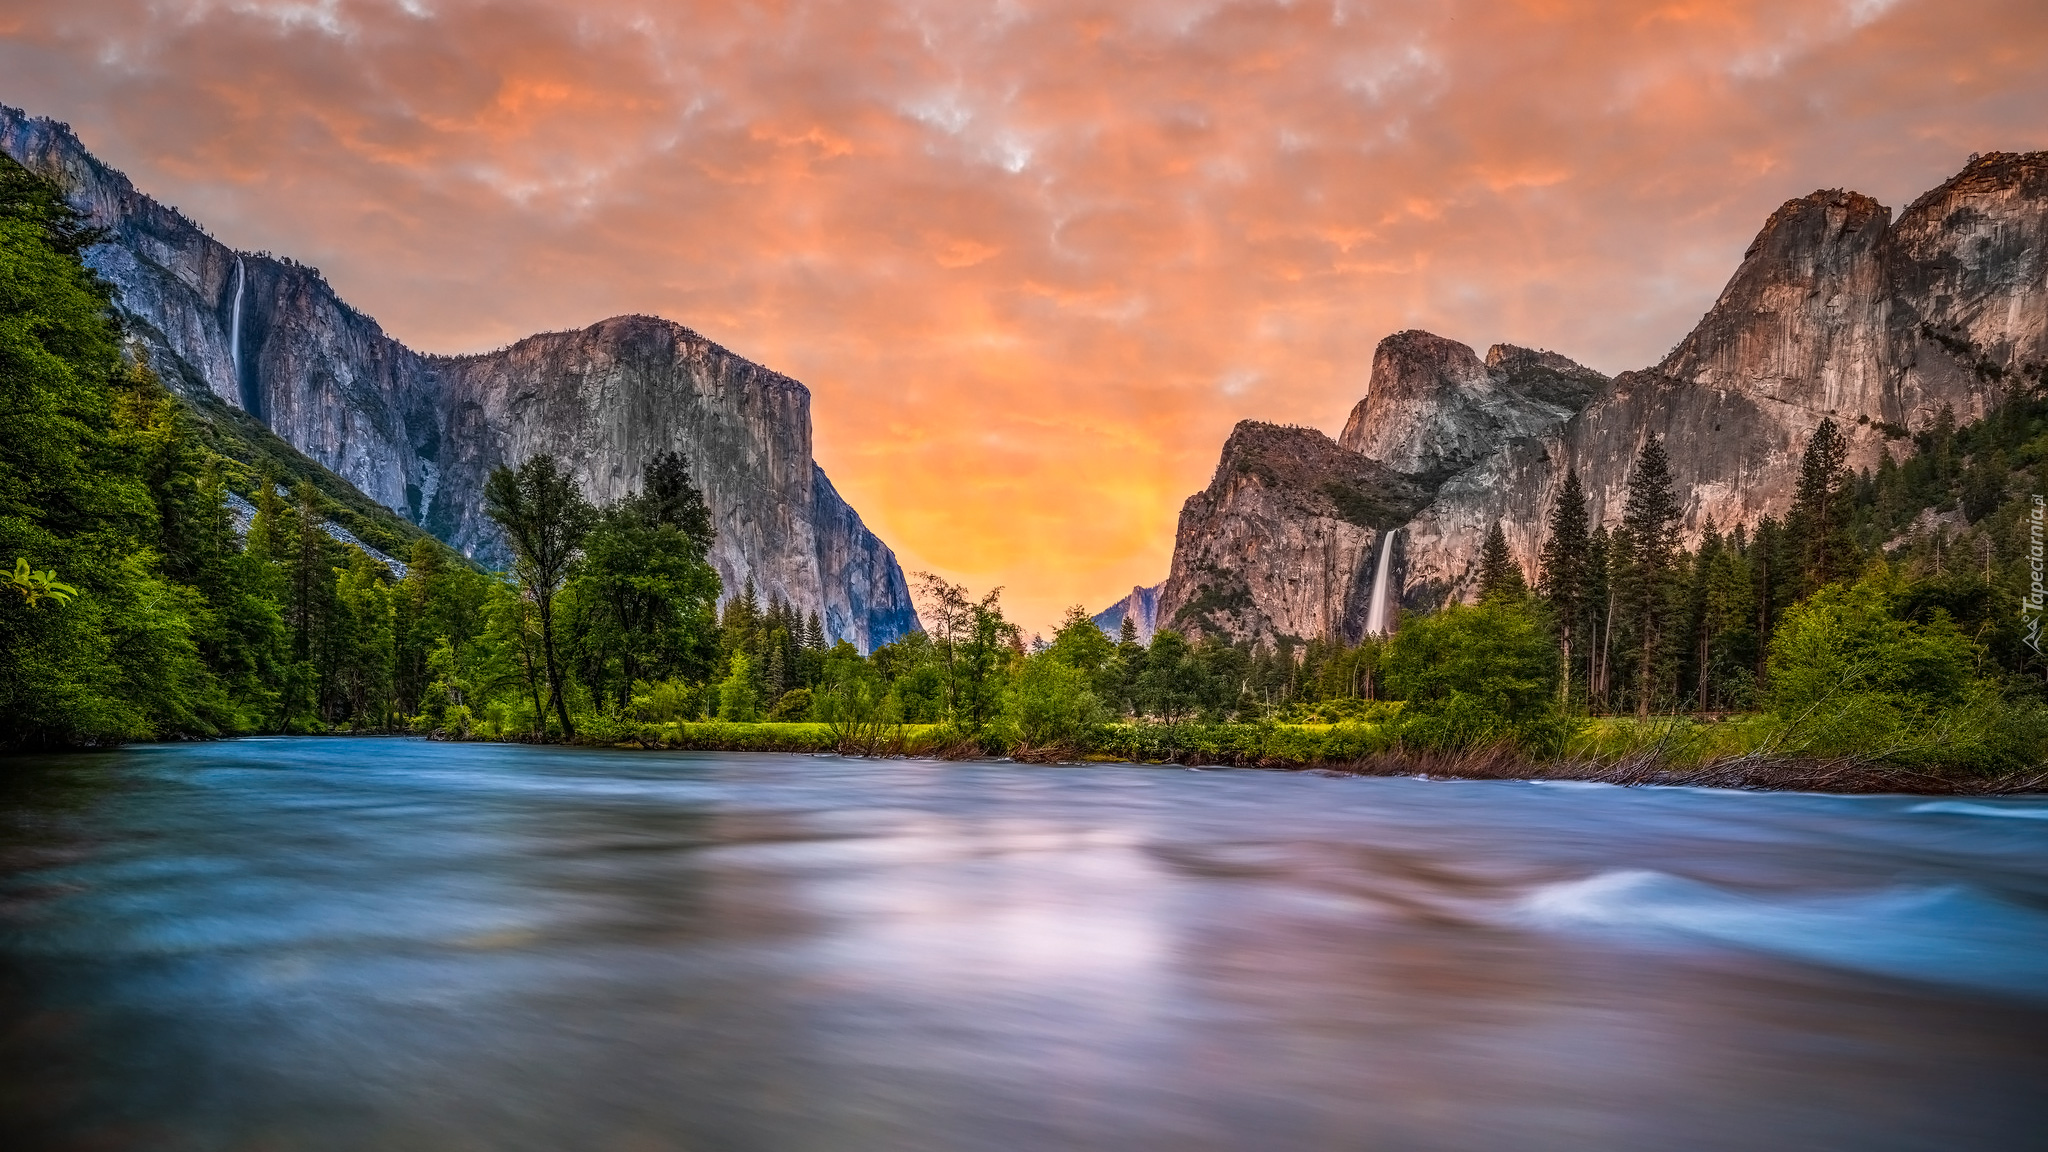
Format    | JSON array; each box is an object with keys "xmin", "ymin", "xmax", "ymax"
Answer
[{"xmin": 0, "ymin": 740, "xmax": 2048, "ymax": 1152}]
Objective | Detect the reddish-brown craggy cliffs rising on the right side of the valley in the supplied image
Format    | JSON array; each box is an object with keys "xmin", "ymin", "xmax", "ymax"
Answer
[{"xmin": 1159, "ymin": 152, "xmax": 2048, "ymax": 640}]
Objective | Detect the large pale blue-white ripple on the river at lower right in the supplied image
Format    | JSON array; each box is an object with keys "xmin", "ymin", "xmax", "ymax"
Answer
[{"xmin": 1520, "ymin": 869, "xmax": 2048, "ymax": 998}]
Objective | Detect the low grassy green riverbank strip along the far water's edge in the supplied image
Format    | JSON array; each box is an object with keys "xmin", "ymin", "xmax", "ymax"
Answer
[{"xmin": 491, "ymin": 717, "xmax": 2048, "ymax": 795}]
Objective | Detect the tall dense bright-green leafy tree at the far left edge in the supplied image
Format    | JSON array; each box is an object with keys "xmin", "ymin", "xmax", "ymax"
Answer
[{"xmin": 0, "ymin": 158, "xmax": 221, "ymax": 744}]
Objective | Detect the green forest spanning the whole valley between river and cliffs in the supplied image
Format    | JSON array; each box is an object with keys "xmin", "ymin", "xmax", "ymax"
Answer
[{"xmin": 0, "ymin": 158, "xmax": 2048, "ymax": 775}]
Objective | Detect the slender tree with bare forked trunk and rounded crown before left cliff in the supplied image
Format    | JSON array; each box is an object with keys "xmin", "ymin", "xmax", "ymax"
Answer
[{"xmin": 483, "ymin": 453, "xmax": 594, "ymax": 736}]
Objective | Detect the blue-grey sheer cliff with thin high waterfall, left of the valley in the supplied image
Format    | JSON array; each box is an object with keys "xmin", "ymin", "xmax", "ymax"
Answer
[{"xmin": 0, "ymin": 107, "xmax": 918, "ymax": 650}]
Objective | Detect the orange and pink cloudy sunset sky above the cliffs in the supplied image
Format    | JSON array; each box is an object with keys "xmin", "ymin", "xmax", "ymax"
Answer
[{"xmin": 0, "ymin": 0, "xmax": 2048, "ymax": 629}]
